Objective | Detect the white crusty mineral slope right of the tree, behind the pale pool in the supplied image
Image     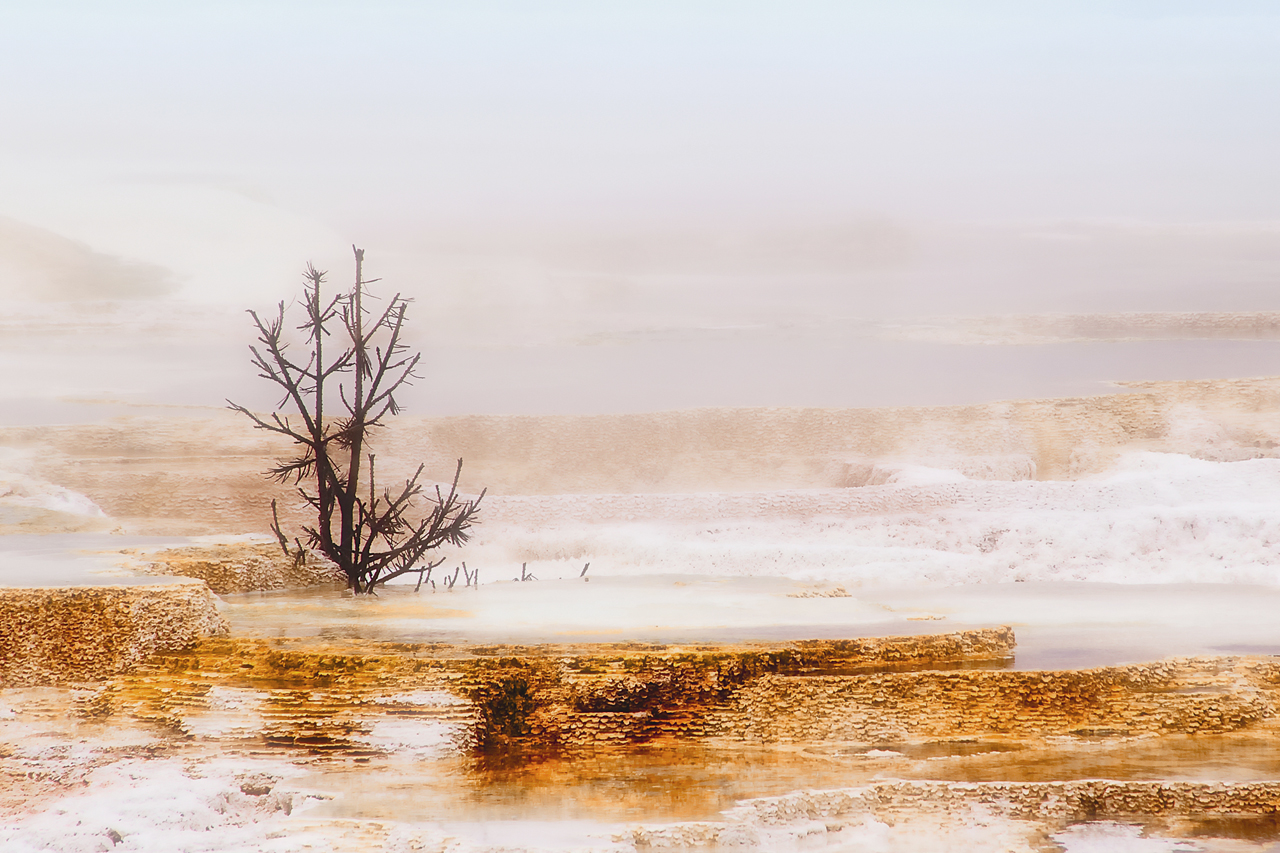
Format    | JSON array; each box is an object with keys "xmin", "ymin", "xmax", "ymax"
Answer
[{"xmin": 463, "ymin": 452, "xmax": 1280, "ymax": 587}]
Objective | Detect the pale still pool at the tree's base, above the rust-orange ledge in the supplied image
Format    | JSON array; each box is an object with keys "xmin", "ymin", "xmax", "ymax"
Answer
[{"xmin": 223, "ymin": 575, "xmax": 1280, "ymax": 670}]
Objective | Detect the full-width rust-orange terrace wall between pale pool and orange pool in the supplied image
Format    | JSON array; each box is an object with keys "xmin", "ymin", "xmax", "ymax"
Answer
[{"xmin": 67, "ymin": 629, "xmax": 1280, "ymax": 756}]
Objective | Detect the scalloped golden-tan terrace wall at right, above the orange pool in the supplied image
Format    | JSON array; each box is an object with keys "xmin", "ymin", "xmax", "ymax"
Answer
[{"xmin": 708, "ymin": 658, "xmax": 1276, "ymax": 743}]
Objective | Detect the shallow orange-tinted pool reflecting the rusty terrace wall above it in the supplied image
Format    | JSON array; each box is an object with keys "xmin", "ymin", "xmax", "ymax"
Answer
[{"xmin": 290, "ymin": 734, "xmax": 1280, "ymax": 824}]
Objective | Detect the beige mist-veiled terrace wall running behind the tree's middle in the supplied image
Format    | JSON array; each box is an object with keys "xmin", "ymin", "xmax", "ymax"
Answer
[{"xmin": 0, "ymin": 378, "xmax": 1280, "ymax": 534}]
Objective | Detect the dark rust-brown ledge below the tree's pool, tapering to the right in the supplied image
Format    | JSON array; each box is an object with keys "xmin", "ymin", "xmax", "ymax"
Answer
[{"xmin": 74, "ymin": 628, "xmax": 1014, "ymax": 753}]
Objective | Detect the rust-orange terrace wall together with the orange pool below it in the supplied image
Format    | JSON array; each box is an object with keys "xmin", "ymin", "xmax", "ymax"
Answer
[{"xmin": 0, "ymin": 629, "xmax": 1280, "ymax": 844}]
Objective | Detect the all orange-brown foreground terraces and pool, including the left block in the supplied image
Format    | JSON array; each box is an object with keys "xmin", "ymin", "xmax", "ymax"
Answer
[{"xmin": 0, "ymin": 557, "xmax": 1280, "ymax": 850}]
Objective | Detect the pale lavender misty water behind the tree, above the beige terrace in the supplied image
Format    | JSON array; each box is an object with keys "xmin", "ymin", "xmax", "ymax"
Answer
[{"xmin": 0, "ymin": 297, "xmax": 1280, "ymax": 425}]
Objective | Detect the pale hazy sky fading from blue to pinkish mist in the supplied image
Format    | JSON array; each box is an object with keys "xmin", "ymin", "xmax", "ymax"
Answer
[{"xmin": 0, "ymin": 0, "xmax": 1280, "ymax": 412}]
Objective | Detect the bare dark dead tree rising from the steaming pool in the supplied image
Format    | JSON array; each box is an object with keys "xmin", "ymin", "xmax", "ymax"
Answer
[{"xmin": 228, "ymin": 246, "xmax": 484, "ymax": 593}]
